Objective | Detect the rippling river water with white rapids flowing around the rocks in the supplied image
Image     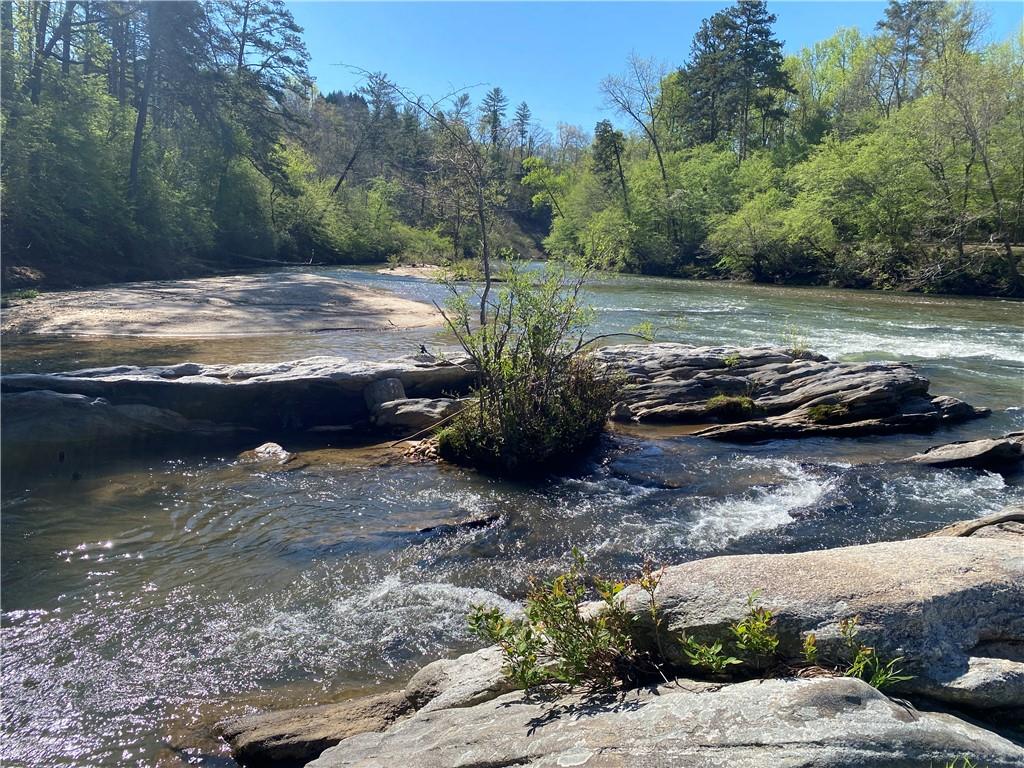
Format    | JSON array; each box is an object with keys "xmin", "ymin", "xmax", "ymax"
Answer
[{"xmin": 0, "ymin": 269, "xmax": 1024, "ymax": 766}]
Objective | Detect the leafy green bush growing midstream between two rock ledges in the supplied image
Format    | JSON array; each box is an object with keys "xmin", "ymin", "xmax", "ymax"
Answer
[{"xmin": 437, "ymin": 262, "xmax": 617, "ymax": 475}]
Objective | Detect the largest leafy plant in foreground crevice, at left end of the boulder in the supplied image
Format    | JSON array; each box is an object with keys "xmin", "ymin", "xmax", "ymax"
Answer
[{"xmin": 469, "ymin": 549, "xmax": 633, "ymax": 689}]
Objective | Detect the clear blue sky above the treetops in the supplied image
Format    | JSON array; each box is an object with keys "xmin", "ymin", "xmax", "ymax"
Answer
[{"xmin": 288, "ymin": 1, "xmax": 1024, "ymax": 131}]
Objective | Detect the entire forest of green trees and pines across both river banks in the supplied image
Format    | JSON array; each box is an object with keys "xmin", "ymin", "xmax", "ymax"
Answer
[{"xmin": 0, "ymin": 0, "xmax": 1024, "ymax": 295}]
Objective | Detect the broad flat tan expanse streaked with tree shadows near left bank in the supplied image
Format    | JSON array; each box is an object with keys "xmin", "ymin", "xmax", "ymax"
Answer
[{"xmin": 2, "ymin": 272, "xmax": 441, "ymax": 337}]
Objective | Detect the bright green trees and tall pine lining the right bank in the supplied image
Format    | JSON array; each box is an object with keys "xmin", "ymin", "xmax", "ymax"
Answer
[{"xmin": 545, "ymin": 2, "xmax": 1024, "ymax": 295}]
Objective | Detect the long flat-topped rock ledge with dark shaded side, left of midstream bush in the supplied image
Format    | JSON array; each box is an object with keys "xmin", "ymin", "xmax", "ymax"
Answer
[{"xmin": 0, "ymin": 355, "xmax": 473, "ymax": 470}]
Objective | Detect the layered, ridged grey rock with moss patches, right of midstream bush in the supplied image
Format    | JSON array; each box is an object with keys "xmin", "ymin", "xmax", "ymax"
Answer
[{"xmin": 596, "ymin": 344, "xmax": 988, "ymax": 441}]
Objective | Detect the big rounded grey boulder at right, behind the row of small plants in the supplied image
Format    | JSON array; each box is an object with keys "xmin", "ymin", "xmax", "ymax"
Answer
[{"xmin": 623, "ymin": 537, "xmax": 1024, "ymax": 710}]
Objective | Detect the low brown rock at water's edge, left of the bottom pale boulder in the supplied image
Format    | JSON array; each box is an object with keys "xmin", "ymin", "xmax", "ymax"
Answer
[{"xmin": 217, "ymin": 691, "xmax": 413, "ymax": 768}]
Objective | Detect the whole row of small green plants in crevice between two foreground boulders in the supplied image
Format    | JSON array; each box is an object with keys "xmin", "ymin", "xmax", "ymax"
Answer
[{"xmin": 469, "ymin": 561, "xmax": 910, "ymax": 690}]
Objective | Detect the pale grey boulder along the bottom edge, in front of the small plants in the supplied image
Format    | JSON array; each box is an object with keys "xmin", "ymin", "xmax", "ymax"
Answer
[{"xmin": 309, "ymin": 678, "xmax": 1024, "ymax": 768}]
